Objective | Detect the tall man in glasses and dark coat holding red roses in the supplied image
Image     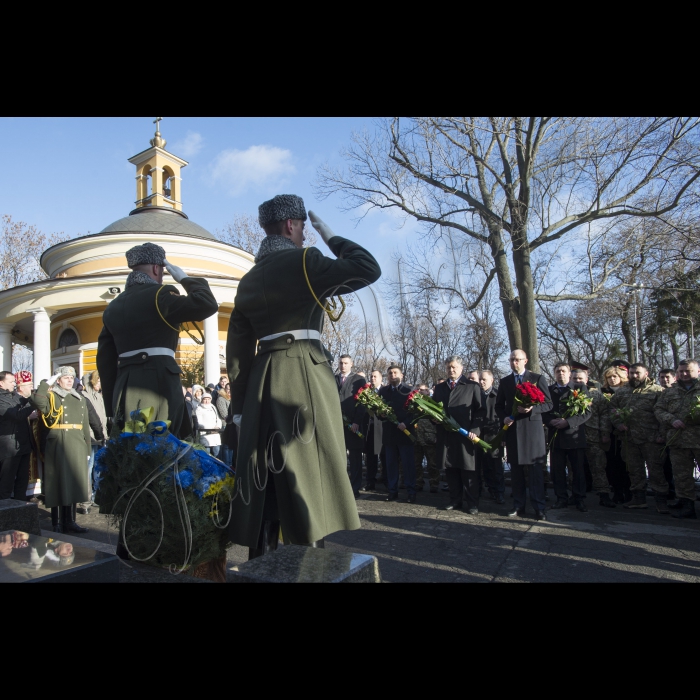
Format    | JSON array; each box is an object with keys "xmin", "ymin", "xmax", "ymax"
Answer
[{"xmin": 496, "ymin": 348, "xmax": 552, "ymax": 520}]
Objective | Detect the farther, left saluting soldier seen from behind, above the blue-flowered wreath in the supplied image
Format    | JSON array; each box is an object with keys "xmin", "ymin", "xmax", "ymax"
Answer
[{"xmin": 97, "ymin": 243, "xmax": 219, "ymax": 438}]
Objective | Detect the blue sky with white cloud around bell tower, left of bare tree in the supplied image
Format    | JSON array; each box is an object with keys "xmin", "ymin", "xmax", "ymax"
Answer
[{"xmin": 0, "ymin": 117, "xmax": 415, "ymax": 272}]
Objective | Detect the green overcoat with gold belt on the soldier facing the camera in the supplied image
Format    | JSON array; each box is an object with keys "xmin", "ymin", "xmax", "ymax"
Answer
[{"xmin": 29, "ymin": 379, "xmax": 91, "ymax": 508}]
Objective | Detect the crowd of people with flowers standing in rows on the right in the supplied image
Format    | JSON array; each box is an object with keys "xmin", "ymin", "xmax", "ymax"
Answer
[{"xmin": 336, "ymin": 349, "xmax": 700, "ymax": 520}]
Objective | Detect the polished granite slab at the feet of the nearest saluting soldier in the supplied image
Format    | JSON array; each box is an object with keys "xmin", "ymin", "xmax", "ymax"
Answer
[{"xmin": 227, "ymin": 545, "xmax": 381, "ymax": 583}]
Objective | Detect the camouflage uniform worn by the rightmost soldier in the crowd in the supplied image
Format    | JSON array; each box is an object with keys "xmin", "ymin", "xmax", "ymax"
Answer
[{"xmin": 655, "ymin": 379, "xmax": 700, "ymax": 510}]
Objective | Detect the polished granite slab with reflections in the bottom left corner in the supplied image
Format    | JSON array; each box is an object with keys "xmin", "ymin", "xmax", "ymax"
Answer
[{"xmin": 0, "ymin": 530, "xmax": 119, "ymax": 583}]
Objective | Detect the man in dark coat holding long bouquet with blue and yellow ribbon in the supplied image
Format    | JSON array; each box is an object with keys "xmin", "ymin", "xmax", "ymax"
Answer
[{"xmin": 433, "ymin": 355, "xmax": 481, "ymax": 515}]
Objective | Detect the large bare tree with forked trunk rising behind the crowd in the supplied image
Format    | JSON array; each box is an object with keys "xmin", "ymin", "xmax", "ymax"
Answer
[{"xmin": 317, "ymin": 117, "xmax": 700, "ymax": 370}]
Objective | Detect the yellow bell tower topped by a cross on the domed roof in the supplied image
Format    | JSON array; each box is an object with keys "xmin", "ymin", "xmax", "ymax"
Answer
[{"xmin": 129, "ymin": 117, "xmax": 187, "ymax": 211}]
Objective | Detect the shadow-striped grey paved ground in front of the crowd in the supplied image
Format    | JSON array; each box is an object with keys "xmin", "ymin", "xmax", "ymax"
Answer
[{"xmin": 34, "ymin": 489, "xmax": 700, "ymax": 583}]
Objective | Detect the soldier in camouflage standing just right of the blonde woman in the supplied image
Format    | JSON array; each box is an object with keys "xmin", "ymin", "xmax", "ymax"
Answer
[{"xmin": 609, "ymin": 363, "xmax": 669, "ymax": 513}]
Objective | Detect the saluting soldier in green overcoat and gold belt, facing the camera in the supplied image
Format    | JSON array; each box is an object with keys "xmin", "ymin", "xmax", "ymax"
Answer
[{"xmin": 29, "ymin": 366, "xmax": 91, "ymax": 532}]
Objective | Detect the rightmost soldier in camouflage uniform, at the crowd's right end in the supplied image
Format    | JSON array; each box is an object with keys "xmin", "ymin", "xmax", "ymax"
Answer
[{"xmin": 655, "ymin": 360, "xmax": 700, "ymax": 518}]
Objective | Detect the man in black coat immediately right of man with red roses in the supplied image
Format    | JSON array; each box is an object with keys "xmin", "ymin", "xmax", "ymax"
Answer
[{"xmin": 542, "ymin": 362, "xmax": 591, "ymax": 513}]
